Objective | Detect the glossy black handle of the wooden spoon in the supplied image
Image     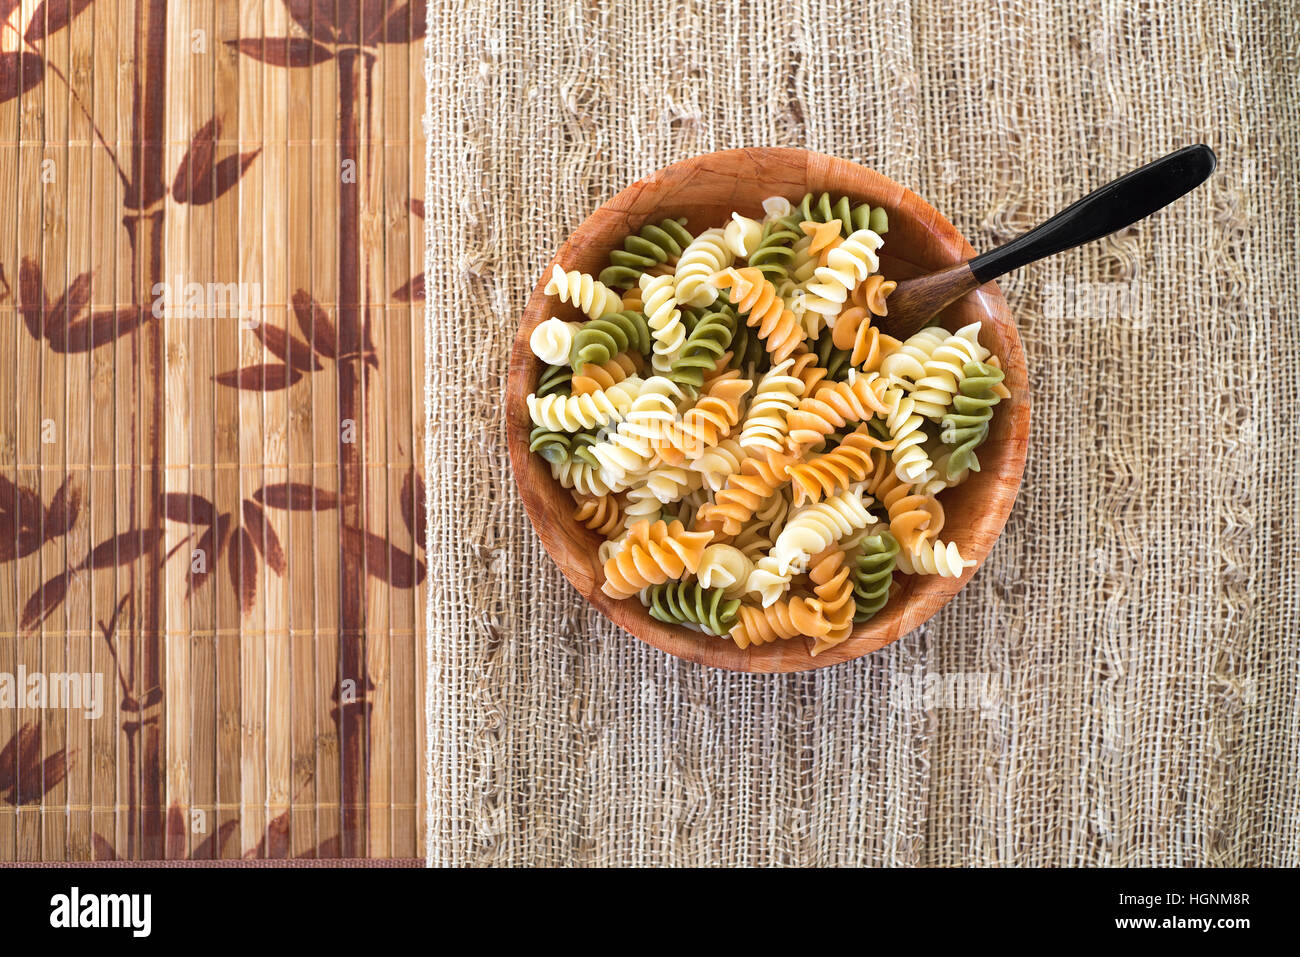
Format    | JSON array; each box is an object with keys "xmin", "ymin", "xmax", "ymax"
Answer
[{"xmin": 970, "ymin": 146, "xmax": 1216, "ymax": 283}]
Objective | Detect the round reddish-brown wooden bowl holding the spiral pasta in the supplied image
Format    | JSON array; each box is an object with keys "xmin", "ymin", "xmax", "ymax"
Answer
[{"xmin": 506, "ymin": 148, "xmax": 1030, "ymax": 672}]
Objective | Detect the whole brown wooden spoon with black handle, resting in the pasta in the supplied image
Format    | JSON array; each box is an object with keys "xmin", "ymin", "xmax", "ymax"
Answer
[{"xmin": 879, "ymin": 146, "xmax": 1216, "ymax": 339}]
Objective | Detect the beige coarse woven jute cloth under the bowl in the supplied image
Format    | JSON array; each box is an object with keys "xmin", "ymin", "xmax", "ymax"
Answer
[{"xmin": 428, "ymin": 0, "xmax": 1300, "ymax": 866}]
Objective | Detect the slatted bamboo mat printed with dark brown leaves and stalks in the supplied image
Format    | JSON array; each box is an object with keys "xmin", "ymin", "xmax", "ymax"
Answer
[{"xmin": 0, "ymin": 0, "xmax": 425, "ymax": 861}]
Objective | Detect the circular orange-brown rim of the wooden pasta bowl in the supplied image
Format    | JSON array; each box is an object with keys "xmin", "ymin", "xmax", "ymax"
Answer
[{"xmin": 506, "ymin": 147, "xmax": 1030, "ymax": 674}]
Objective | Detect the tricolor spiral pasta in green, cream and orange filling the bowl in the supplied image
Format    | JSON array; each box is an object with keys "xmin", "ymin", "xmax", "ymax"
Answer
[{"xmin": 525, "ymin": 194, "xmax": 1010, "ymax": 657}]
